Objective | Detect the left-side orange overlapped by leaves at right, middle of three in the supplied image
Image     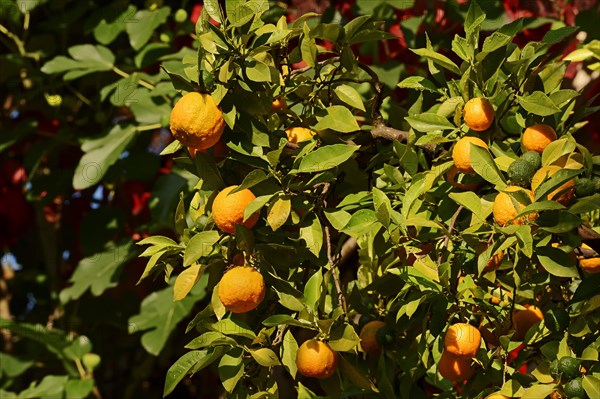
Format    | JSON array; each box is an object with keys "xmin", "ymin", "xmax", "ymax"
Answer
[{"xmin": 212, "ymin": 186, "xmax": 259, "ymax": 234}]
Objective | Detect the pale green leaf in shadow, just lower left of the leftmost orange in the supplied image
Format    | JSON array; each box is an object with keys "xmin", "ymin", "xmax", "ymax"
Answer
[{"xmin": 73, "ymin": 125, "xmax": 136, "ymax": 190}]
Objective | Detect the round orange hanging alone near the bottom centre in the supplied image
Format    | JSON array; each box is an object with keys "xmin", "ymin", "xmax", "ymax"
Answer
[{"xmin": 296, "ymin": 339, "xmax": 337, "ymax": 378}]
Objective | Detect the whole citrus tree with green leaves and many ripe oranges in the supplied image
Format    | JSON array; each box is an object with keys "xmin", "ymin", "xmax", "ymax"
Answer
[{"xmin": 132, "ymin": 1, "xmax": 600, "ymax": 398}]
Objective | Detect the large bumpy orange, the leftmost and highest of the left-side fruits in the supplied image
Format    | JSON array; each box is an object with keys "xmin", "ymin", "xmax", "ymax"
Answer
[{"xmin": 170, "ymin": 92, "xmax": 225, "ymax": 153}]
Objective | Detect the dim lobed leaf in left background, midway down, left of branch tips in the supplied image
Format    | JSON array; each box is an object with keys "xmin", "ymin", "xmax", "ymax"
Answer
[{"xmin": 60, "ymin": 241, "xmax": 136, "ymax": 303}]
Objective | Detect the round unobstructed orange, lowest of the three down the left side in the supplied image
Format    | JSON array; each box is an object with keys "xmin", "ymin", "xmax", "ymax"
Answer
[{"xmin": 219, "ymin": 266, "xmax": 266, "ymax": 313}]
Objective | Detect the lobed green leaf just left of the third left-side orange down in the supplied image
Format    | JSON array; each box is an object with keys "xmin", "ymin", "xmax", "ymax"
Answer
[{"xmin": 129, "ymin": 274, "xmax": 208, "ymax": 356}]
